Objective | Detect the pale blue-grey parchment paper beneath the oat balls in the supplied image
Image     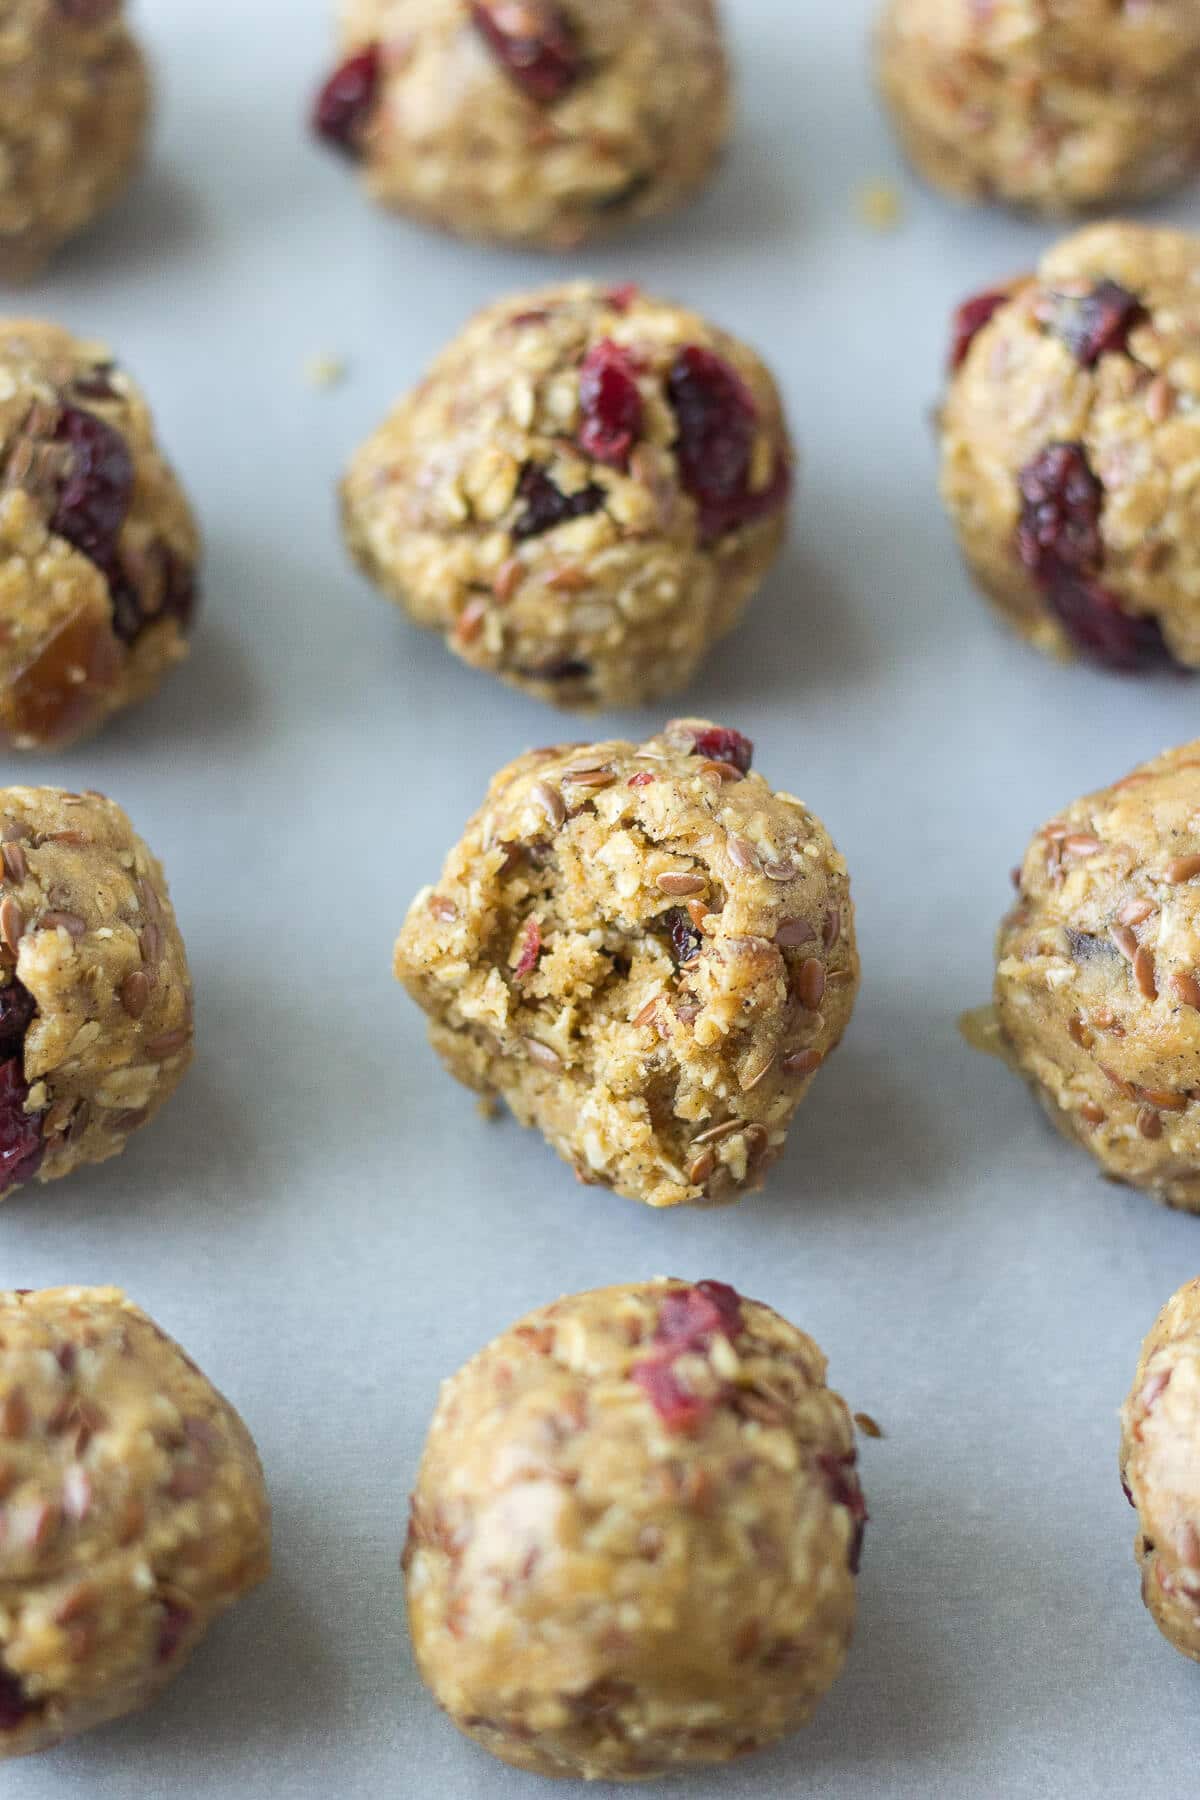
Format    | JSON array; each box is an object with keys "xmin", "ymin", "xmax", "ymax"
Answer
[{"xmin": 0, "ymin": 0, "xmax": 1200, "ymax": 1800}]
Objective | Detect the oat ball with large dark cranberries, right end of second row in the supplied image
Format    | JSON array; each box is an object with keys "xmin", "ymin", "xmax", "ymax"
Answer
[{"xmin": 941, "ymin": 225, "xmax": 1200, "ymax": 671}]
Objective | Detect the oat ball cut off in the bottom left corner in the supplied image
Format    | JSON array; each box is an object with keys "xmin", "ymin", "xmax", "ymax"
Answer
[{"xmin": 0, "ymin": 1287, "xmax": 270, "ymax": 1760}]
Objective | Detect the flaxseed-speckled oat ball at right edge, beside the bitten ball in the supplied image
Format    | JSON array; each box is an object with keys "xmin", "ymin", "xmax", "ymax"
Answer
[{"xmin": 995, "ymin": 742, "xmax": 1200, "ymax": 1211}]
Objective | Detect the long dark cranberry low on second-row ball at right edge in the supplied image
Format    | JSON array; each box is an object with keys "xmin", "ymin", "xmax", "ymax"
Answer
[{"xmin": 1016, "ymin": 443, "xmax": 1171, "ymax": 671}]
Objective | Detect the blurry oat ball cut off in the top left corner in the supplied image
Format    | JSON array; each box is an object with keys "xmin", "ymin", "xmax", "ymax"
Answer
[{"xmin": 0, "ymin": 0, "xmax": 149, "ymax": 281}]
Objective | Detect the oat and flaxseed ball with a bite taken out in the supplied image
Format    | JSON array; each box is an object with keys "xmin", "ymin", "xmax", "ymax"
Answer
[{"xmin": 396, "ymin": 718, "xmax": 858, "ymax": 1206}]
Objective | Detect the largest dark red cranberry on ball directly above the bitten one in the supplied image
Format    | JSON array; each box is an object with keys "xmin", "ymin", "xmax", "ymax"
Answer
[{"xmin": 667, "ymin": 344, "xmax": 792, "ymax": 540}]
